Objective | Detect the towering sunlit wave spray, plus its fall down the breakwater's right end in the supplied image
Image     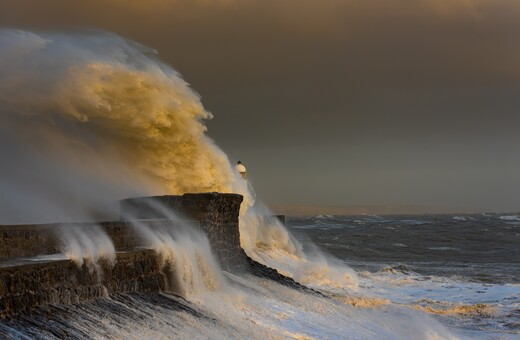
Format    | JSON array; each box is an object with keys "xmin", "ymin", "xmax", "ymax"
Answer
[{"xmin": 0, "ymin": 30, "xmax": 356, "ymax": 286}]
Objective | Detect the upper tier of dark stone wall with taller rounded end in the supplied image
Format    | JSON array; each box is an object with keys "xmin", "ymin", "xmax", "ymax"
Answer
[{"xmin": 0, "ymin": 193, "xmax": 243, "ymax": 269}]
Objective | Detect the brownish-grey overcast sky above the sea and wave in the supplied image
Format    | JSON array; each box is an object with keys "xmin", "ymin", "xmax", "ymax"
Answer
[{"xmin": 0, "ymin": 0, "xmax": 520, "ymax": 211}]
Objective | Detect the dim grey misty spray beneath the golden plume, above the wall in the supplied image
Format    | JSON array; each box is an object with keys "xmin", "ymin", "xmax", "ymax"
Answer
[{"xmin": 0, "ymin": 129, "xmax": 127, "ymax": 224}]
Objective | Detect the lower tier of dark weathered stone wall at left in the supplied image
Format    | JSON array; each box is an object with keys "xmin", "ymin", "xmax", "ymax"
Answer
[{"xmin": 0, "ymin": 250, "xmax": 164, "ymax": 317}]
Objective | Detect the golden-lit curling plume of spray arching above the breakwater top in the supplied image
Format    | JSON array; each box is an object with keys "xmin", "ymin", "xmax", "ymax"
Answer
[{"xmin": 0, "ymin": 30, "xmax": 252, "ymax": 203}]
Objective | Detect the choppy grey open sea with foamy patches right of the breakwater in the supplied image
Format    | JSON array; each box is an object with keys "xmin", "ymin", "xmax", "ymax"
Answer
[{"xmin": 288, "ymin": 214, "xmax": 520, "ymax": 338}]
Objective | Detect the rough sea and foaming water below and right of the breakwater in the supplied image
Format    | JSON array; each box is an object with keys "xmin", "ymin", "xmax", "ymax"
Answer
[{"xmin": 5, "ymin": 215, "xmax": 520, "ymax": 339}]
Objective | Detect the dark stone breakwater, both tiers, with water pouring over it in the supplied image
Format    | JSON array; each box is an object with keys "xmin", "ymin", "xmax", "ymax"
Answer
[{"xmin": 0, "ymin": 193, "xmax": 296, "ymax": 318}]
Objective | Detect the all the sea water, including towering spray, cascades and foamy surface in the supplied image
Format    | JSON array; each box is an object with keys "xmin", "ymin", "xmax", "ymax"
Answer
[{"xmin": 0, "ymin": 30, "xmax": 520, "ymax": 339}]
